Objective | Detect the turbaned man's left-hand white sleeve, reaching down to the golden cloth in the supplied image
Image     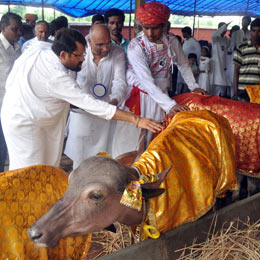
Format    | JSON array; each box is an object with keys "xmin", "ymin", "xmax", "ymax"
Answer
[{"xmin": 127, "ymin": 41, "xmax": 176, "ymax": 113}]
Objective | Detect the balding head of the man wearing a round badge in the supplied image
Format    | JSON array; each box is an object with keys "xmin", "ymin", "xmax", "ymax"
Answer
[{"xmin": 88, "ymin": 24, "xmax": 111, "ymax": 58}]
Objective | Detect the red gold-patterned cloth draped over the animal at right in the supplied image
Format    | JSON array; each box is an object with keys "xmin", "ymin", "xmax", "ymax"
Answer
[{"xmin": 171, "ymin": 93, "xmax": 260, "ymax": 177}]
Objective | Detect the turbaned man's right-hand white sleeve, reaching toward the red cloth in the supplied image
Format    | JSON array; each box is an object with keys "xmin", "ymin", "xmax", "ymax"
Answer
[{"xmin": 170, "ymin": 38, "xmax": 199, "ymax": 91}]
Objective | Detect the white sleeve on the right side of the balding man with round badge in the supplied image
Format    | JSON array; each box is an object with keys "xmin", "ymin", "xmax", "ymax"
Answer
[{"xmin": 109, "ymin": 49, "xmax": 126, "ymax": 104}]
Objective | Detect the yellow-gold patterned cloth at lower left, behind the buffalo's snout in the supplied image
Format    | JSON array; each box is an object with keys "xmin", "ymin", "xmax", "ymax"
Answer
[{"xmin": 0, "ymin": 165, "xmax": 91, "ymax": 260}]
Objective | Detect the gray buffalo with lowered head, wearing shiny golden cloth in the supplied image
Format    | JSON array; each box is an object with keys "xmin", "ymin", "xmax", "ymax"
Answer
[{"xmin": 28, "ymin": 111, "xmax": 237, "ymax": 247}]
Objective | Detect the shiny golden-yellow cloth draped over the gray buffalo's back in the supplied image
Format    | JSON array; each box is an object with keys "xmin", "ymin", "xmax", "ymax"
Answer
[{"xmin": 134, "ymin": 111, "xmax": 237, "ymax": 232}]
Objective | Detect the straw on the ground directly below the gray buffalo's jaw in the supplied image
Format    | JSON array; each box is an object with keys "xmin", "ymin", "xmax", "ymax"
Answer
[{"xmin": 86, "ymin": 223, "xmax": 139, "ymax": 260}]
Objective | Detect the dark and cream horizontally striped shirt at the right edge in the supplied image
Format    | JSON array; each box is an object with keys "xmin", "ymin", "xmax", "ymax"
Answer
[{"xmin": 233, "ymin": 40, "xmax": 260, "ymax": 90}]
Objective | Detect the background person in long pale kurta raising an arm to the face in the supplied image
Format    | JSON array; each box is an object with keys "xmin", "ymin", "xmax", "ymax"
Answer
[{"xmin": 211, "ymin": 23, "xmax": 230, "ymax": 96}]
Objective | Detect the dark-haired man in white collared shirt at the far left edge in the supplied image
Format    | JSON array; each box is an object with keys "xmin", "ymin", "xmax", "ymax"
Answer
[{"xmin": 0, "ymin": 13, "xmax": 22, "ymax": 172}]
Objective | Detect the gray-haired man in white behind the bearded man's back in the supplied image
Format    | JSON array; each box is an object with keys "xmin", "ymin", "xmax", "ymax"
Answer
[{"xmin": 22, "ymin": 21, "xmax": 50, "ymax": 52}]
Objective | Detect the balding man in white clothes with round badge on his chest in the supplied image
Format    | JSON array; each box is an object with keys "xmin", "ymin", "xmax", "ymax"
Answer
[{"xmin": 65, "ymin": 24, "xmax": 126, "ymax": 169}]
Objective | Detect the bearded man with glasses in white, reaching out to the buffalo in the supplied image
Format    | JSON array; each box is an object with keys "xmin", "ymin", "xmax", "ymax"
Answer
[{"xmin": 1, "ymin": 29, "xmax": 161, "ymax": 170}]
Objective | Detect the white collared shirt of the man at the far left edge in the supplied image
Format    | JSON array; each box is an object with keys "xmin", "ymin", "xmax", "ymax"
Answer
[{"xmin": 0, "ymin": 33, "xmax": 21, "ymax": 110}]
